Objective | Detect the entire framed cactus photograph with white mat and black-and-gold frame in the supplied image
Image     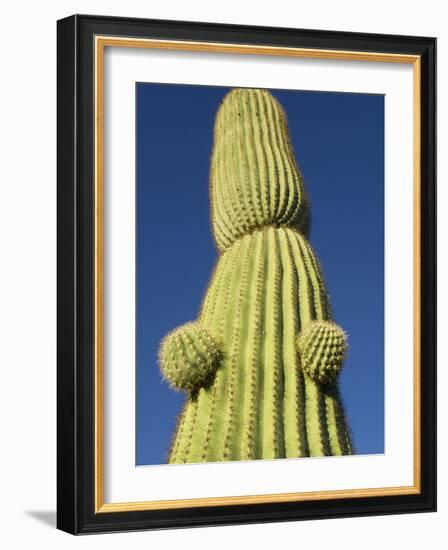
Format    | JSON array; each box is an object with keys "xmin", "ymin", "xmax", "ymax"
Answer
[{"xmin": 57, "ymin": 15, "xmax": 436, "ymax": 534}]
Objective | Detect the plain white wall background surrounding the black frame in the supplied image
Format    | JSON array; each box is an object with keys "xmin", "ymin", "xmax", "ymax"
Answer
[{"xmin": 0, "ymin": 0, "xmax": 440, "ymax": 550}]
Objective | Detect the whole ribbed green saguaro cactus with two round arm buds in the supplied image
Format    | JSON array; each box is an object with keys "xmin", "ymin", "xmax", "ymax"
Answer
[{"xmin": 160, "ymin": 89, "xmax": 352, "ymax": 463}]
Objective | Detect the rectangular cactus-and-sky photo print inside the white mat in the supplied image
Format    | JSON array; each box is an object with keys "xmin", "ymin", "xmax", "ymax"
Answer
[{"xmin": 136, "ymin": 82, "xmax": 384, "ymax": 465}]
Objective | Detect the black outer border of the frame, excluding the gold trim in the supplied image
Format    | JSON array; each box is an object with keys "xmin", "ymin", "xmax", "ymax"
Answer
[{"xmin": 57, "ymin": 15, "xmax": 436, "ymax": 534}]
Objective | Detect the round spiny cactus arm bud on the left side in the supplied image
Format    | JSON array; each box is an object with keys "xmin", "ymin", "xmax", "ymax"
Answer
[{"xmin": 159, "ymin": 322, "xmax": 221, "ymax": 392}]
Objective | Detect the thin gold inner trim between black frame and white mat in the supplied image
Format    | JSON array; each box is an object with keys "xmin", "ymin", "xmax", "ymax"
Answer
[{"xmin": 94, "ymin": 36, "xmax": 421, "ymax": 513}]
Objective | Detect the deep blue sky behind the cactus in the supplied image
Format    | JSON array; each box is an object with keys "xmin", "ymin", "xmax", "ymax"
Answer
[{"xmin": 136, "ymin": 83, "xmax": 384, "ymax": 464}]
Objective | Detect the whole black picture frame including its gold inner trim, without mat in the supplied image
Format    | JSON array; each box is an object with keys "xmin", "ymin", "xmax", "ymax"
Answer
[{"xmin": 57, "ymin": 15, "xmax": 436, "ymax": 534}]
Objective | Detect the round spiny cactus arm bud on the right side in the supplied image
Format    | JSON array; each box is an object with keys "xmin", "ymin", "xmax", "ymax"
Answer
[{"xmin": 297, "ymin": 321, "xmax": 347, "ymax": 384}]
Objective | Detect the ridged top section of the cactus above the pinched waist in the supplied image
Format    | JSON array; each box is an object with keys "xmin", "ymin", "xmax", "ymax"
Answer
[{"xmin": 211, "ymin": 90, "xmax": 309, "ymax": 250}]
